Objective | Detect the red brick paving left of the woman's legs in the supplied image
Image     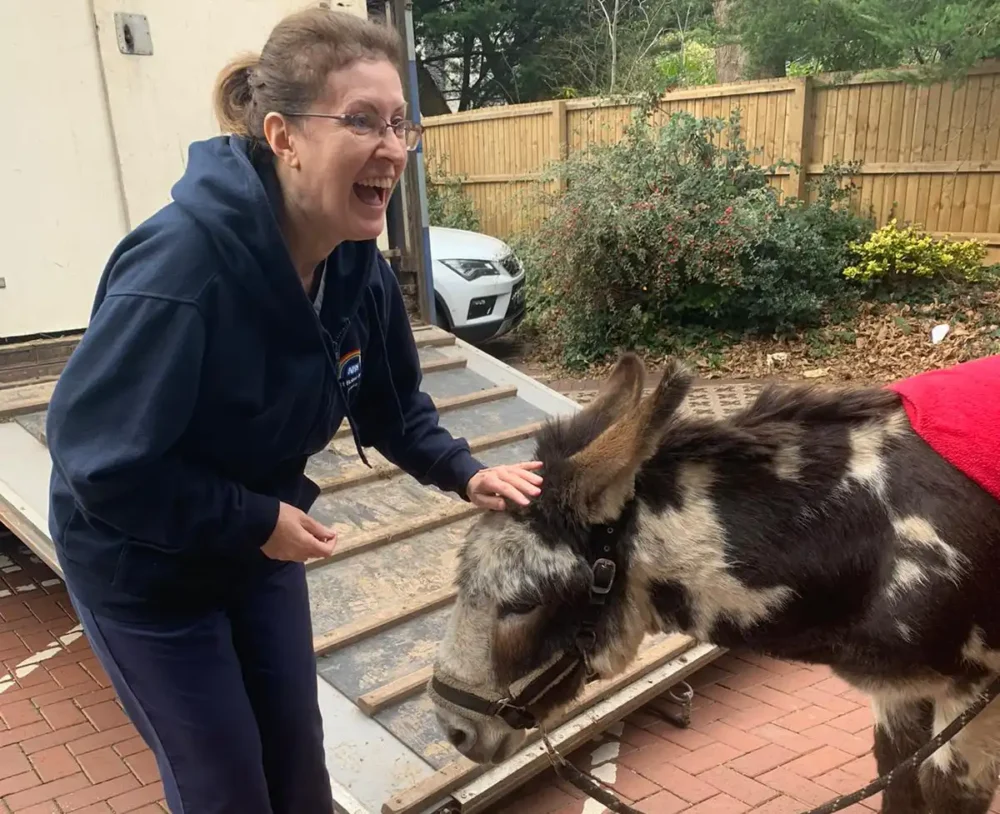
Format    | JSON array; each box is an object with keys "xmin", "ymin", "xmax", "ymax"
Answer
[{"xmin": 0, "ymin": 527, "xmax": 167, "ymax": 814}]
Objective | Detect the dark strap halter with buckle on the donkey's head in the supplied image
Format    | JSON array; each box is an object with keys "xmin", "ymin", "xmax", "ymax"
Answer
[{"xmin": 431, "ymin": 516, "xmax": 626, "ymax": 729}]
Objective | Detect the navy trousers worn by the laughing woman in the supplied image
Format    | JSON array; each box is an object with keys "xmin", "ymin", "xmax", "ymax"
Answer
[{"xmin": 71, "ymin": 563, "xmax": 334, "ymax": 814}]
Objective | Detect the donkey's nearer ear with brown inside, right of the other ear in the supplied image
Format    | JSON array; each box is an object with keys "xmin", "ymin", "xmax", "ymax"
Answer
[{"xmin": 570, "ymin": 360, "xmax": 692, "ymax": 523}]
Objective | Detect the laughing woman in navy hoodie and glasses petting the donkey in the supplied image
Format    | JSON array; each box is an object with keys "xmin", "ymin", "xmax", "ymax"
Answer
[{"xmin": 47, "ymin": 8, "xmax": 541, "ymax": 814}]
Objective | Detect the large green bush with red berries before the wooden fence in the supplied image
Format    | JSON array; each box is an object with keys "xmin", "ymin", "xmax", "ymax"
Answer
[{"xmin": 519, "ymin": 107, "xmax": 872, "ymax": 366}]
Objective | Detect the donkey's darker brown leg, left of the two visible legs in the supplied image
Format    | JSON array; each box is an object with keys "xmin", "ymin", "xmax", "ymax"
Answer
[{"xmin": 872, "ymin": 693, "xmax": 934, "ymax": 814}]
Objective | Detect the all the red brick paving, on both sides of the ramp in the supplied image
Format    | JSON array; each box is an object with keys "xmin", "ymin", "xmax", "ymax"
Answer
[{"xmin": 0, "ymin": 527, "xmax": 1000, "ymax": 814}]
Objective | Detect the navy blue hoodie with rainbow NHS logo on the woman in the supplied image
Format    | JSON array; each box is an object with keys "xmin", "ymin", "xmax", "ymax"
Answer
[{"xmin": 46, "ymin": 136, "xmax": 482, "ymax": 617}]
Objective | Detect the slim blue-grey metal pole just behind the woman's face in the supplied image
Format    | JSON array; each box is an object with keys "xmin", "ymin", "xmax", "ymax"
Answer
[{"xmin": 392, "ymin": 0, "xmax": 436, "ymax": 325}]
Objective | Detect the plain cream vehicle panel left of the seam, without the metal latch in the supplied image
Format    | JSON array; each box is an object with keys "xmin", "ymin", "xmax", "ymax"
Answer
[{"xmin": 0, "ymin": 0, "xmax": 131, "ymax": 339}]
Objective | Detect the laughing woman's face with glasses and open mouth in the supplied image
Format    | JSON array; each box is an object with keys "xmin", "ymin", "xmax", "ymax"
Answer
[{"xmin": 270, "ymin": 60, "xmax": 407, "ymax": 242}]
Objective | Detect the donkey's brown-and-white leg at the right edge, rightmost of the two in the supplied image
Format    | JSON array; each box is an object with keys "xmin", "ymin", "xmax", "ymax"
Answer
[{"xmin": 920, "ymin": 696, "xmax": 1000, "ymax": 814}]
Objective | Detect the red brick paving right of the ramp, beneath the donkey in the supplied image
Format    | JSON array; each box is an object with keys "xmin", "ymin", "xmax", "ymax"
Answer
[{"xmin": 490, "ymin": 653, "xmax": 1000, "ymax": 814}]
